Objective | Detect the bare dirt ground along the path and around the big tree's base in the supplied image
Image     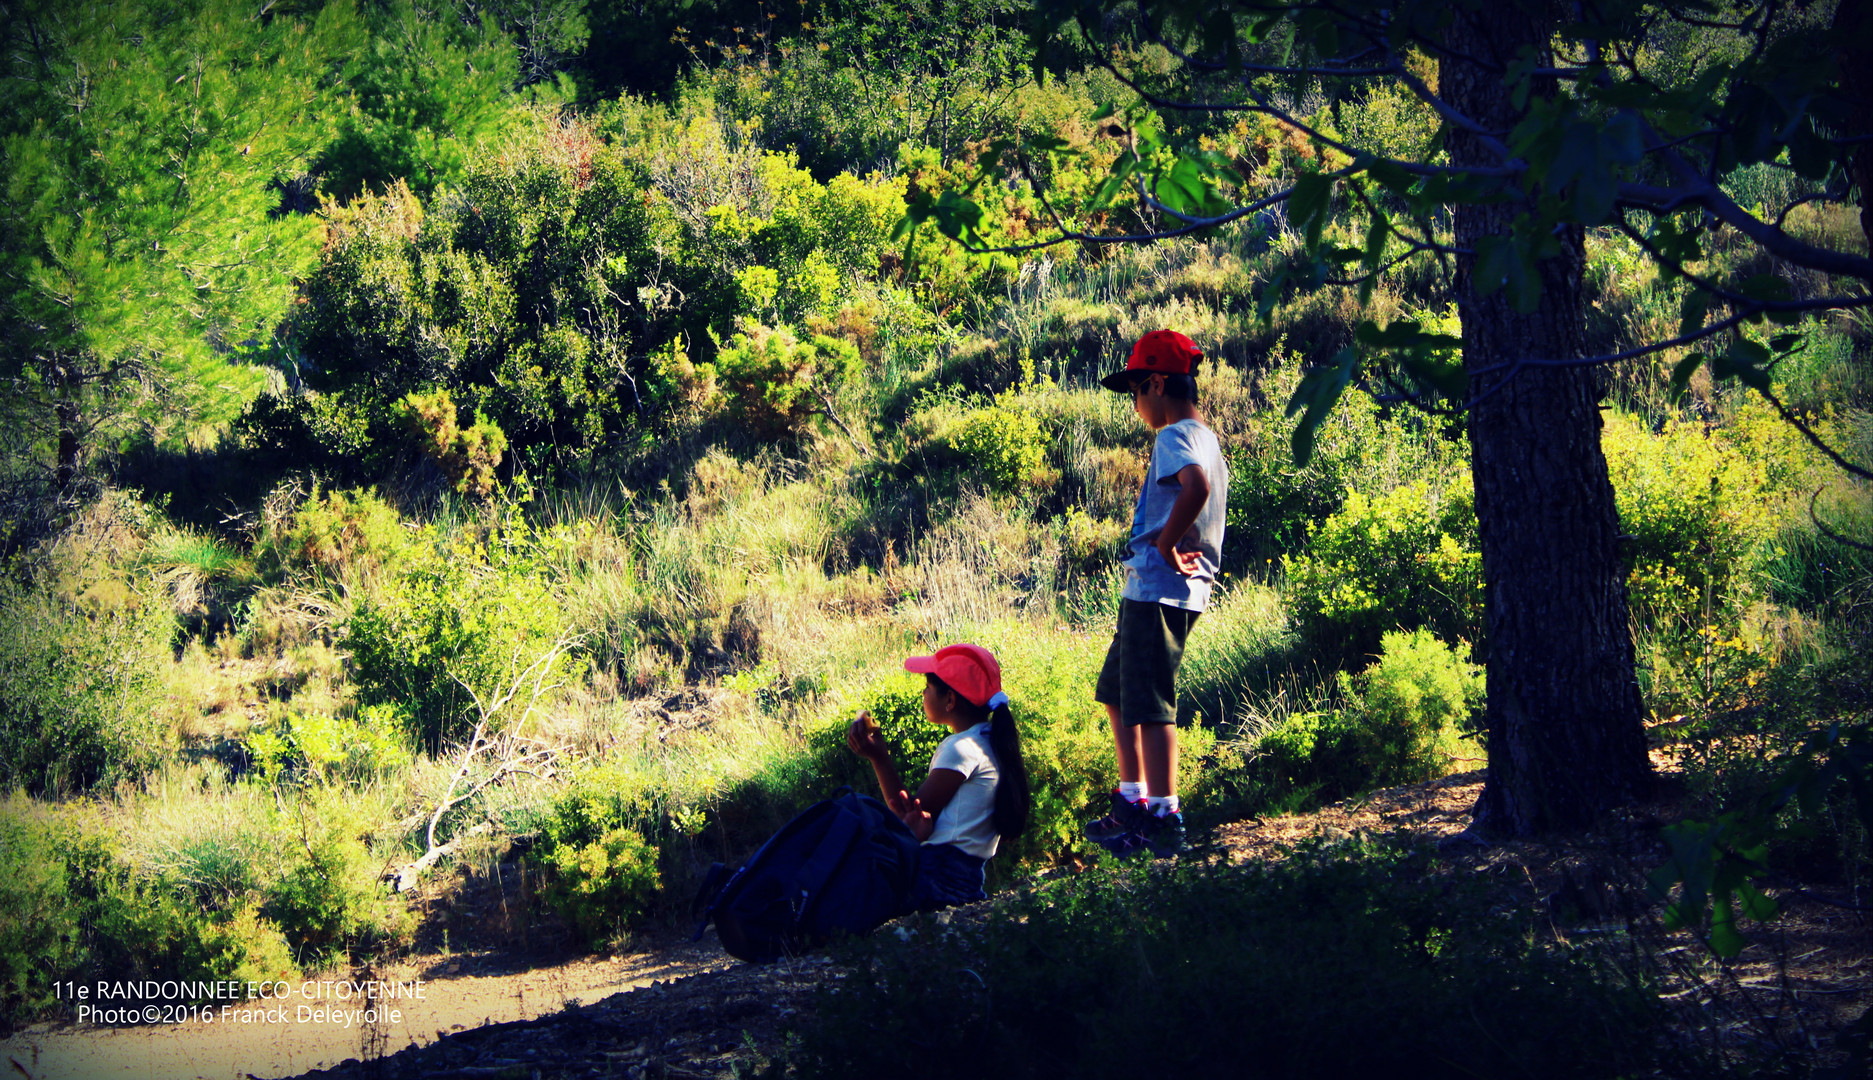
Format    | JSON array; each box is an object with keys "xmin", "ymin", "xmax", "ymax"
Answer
[{"xmin": 4, "ymin": 762, "xmax": 1873, "ymax": 1080}]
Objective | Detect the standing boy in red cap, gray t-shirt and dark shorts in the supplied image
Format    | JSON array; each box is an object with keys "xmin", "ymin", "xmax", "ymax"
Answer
[{"xmin": 1086, "ymin": 329, "xmax": 1229, "ymax": 857}]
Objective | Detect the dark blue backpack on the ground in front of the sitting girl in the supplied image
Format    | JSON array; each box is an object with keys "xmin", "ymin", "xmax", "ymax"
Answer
[{"xmin": 695, "ymin": 788, "xmax": 920, "ymax": 962}]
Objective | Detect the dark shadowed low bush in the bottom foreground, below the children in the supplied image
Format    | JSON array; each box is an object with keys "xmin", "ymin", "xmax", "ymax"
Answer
[{"xmin": 790, "ymin": 848, "xmax": 1658, "ymax": 1080}]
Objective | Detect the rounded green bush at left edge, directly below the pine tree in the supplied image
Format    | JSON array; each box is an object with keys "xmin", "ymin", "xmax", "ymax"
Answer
[{"xmin": 0, "ymin": 571, "xmax": 176, "ymax": 794}]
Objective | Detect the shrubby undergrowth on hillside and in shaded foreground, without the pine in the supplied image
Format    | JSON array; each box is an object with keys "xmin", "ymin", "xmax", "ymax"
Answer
[{"xmin": 0, "ymin": 6, "xmax": 1873, "ymax": 1076}]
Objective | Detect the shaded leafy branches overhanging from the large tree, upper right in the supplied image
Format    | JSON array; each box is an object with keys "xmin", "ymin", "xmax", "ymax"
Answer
[{"xmin": 899, "ymin": 0, "xmax": 1873, "ymax": 464}]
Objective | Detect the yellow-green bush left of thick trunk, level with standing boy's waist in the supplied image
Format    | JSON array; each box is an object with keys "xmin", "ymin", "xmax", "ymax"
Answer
[{"xmin": 1287, "ymin": 483, "xmax": 1483, "ymax": 659}]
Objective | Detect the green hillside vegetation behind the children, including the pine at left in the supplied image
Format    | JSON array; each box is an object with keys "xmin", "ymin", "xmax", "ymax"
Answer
[{"xmin": 0, "ymin": 0, "xmax": 1873, "ymax": 1074}]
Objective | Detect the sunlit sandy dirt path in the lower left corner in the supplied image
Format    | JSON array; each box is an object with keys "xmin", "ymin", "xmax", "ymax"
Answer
[{"xmin": 0, "ymin": 938, "xmax": 734, "ymax": 1080}]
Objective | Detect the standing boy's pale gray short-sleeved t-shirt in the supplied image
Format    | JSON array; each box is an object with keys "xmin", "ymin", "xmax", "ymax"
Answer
[{"xmin": 1122, "ymin": 419, "xmax": 1229, "ymax": 612}]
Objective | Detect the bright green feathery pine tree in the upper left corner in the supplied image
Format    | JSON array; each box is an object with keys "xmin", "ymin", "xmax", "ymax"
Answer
[{"xmin": 0, "ymin": 0, "xmax": 361, "ymax": 489}]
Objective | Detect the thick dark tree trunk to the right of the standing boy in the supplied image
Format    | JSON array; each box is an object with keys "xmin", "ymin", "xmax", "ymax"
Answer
[{"xmin": 1438, "ymin": 2, "xmax": 1652, "ymax": 837}]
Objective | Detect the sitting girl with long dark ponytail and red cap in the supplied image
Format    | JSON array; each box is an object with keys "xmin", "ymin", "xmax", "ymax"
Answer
[{"xmin": 845, "ymin": 646, "xmax": 1028, "ymax": 912}]
